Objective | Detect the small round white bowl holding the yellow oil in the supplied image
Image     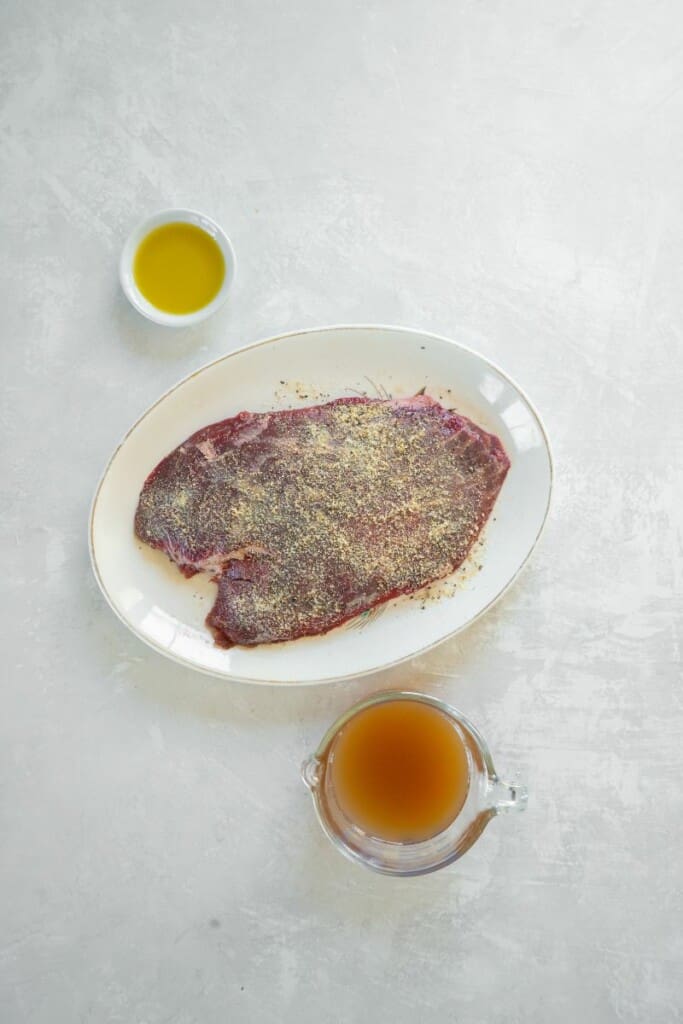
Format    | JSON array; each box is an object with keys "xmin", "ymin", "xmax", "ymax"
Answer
[{"xmin": 119, "ymin": 210, "xmax": 236, "ymax": 327}]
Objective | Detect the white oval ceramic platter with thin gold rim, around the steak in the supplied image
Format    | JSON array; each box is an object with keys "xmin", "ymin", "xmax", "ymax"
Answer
[{"xmin": 90, "ymin": 326, "xmax": 552, "ymax": 684}]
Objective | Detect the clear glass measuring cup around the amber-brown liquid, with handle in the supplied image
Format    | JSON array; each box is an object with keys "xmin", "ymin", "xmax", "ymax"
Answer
[{"xmin": 301, "ymin": 690, "xmax": 527, "ymax": 876}]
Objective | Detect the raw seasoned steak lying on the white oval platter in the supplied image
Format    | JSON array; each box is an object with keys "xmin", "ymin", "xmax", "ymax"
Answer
[{"xmin": 135, "ymin": 395, "xmax": 509, "ymax": 646}]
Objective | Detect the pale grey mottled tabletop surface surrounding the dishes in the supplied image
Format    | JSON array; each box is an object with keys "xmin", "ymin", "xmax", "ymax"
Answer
[{"xmin": 0, "ymin": 0, "xmax": 683, "ymax": 1024}]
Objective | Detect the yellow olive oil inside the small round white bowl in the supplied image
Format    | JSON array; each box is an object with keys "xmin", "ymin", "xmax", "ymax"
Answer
[{"xmin": 133, "ymin": 221, "xmax": 225, "ymax": 315}]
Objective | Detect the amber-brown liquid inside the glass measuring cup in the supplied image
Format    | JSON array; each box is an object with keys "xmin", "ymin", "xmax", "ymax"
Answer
[{"xmin": 329, "ymin": 699, "xmax": 469, "ymax": 843}]
